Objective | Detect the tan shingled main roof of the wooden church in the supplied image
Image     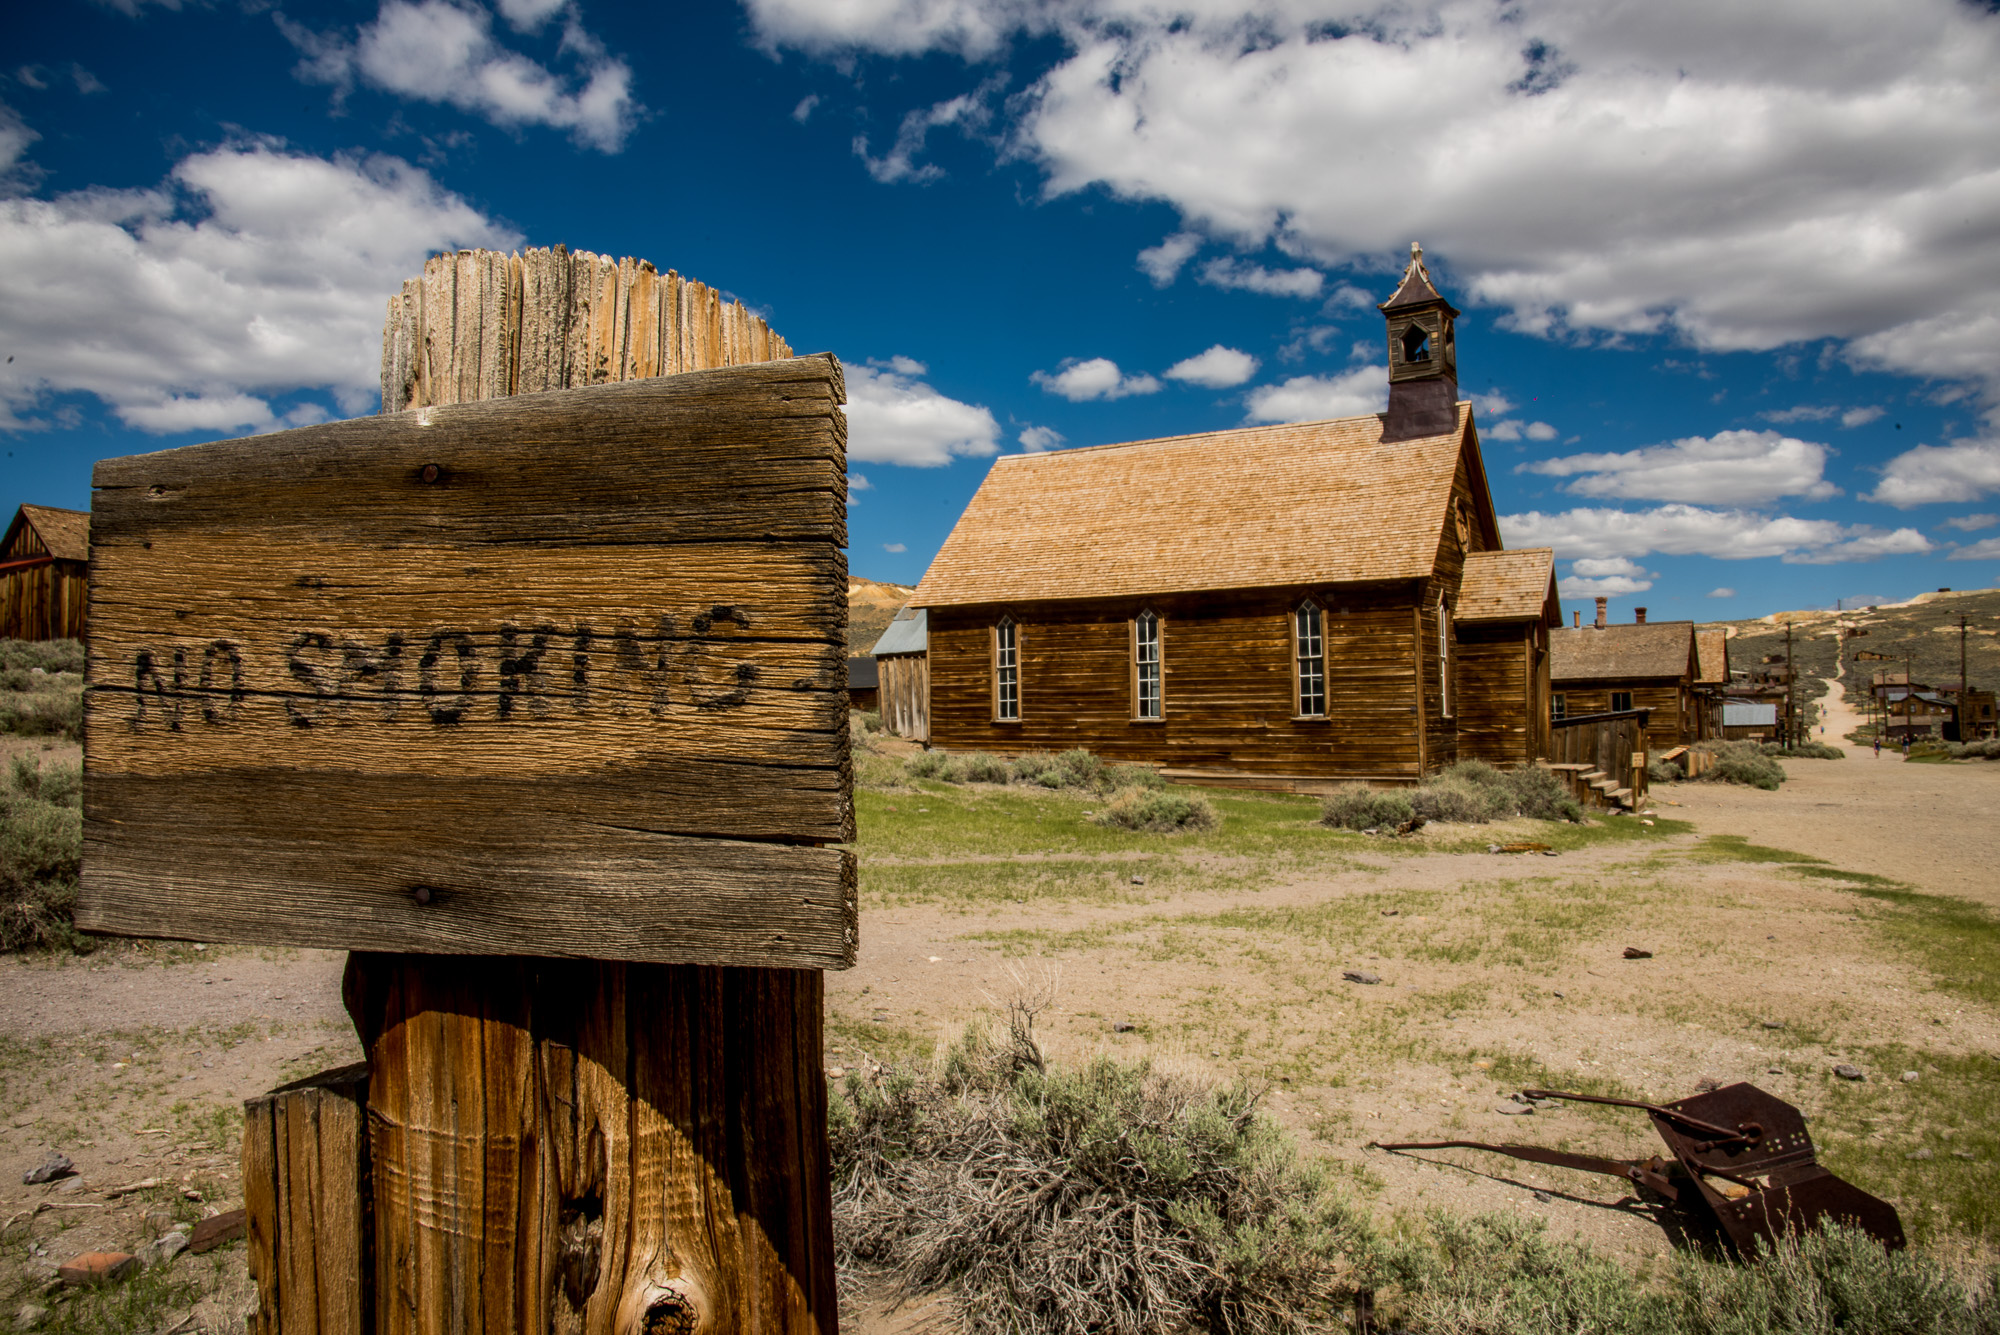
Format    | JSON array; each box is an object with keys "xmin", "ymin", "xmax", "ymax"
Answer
[{"xmin": 910, "ymin": 404, "xmax": 1486, "ymax": 608}]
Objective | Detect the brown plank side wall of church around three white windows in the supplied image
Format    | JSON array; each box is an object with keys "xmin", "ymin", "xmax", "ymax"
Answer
[{"xmin": 930, "ymin": 584, "xmax": 1436, "ymax": 777}]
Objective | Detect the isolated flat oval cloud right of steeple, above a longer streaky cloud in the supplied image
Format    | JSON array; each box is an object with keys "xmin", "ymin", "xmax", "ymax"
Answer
[{"xmin": 1522, "ymin": 432, "xmax": 1840, "ymax": 506}]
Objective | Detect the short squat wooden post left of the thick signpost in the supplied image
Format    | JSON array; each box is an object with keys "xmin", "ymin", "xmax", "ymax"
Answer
[{"xmin": 242, "ymin": 1065, "xmax": 374, "ymax": 1335}]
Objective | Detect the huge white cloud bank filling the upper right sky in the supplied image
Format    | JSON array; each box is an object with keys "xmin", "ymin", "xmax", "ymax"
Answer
[{"xmin": 748, "ymin": 0, "xmax": 2000, "ymax": 401}]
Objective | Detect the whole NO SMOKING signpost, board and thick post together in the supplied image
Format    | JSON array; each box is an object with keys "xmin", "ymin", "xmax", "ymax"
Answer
[{"xmin": 78, "ymin": 248, "xmax": 856, "ymax": 1335}]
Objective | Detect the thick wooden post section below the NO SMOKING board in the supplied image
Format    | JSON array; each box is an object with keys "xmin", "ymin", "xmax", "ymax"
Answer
[{"xmin": 348, "ymin": 955, "xmax": 836, "ymax": 1335}]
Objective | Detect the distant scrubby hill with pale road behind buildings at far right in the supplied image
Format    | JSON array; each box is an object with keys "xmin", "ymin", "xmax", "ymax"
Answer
[{"xmin": 1704, "ymin": 590, "xmax": 2000, "ymax": 699}]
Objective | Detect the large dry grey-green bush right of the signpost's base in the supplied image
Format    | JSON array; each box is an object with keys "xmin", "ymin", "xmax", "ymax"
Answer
[{"xmin": 830, "ymin": 1005, "xmax": 1364, "ymax": 1335}]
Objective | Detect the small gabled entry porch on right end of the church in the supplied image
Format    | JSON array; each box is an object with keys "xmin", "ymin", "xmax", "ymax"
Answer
[{"xmin": 1452, "ymin": 548, "xmax": 1562, "ymax": 769}]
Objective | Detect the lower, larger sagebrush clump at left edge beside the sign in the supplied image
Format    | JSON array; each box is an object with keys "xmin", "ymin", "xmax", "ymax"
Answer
[{"xmin": 0, "ymin": 755, "xmax": 88, "ymax": 949}]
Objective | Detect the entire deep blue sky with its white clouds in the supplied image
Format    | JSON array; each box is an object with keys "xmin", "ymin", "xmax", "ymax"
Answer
[{"xmin": 0, "ymin": 0, "xmax": 2000, "ymax": 620}]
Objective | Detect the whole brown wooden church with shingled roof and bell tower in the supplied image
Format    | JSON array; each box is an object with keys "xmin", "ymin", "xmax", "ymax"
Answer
[{"xmin": 916, "ymin": 252, "xmax": 1560, "ymax": 791}]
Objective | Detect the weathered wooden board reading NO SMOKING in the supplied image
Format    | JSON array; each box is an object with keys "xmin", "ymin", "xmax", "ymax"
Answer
[{"xmin": 76, "ymin": 356, "xmax": 856, "ymax": 967}]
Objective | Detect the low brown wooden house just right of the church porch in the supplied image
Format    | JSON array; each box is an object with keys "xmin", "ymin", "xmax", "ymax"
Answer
[{"xmin": 1550, "ymin": 598, "xmax": 1700, "ymax": 749}]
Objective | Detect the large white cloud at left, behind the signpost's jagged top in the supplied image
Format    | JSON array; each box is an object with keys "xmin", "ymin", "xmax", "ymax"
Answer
[{"xmin": 0, "ymin": 134, "xmax": 520, "ymax": 432}]
